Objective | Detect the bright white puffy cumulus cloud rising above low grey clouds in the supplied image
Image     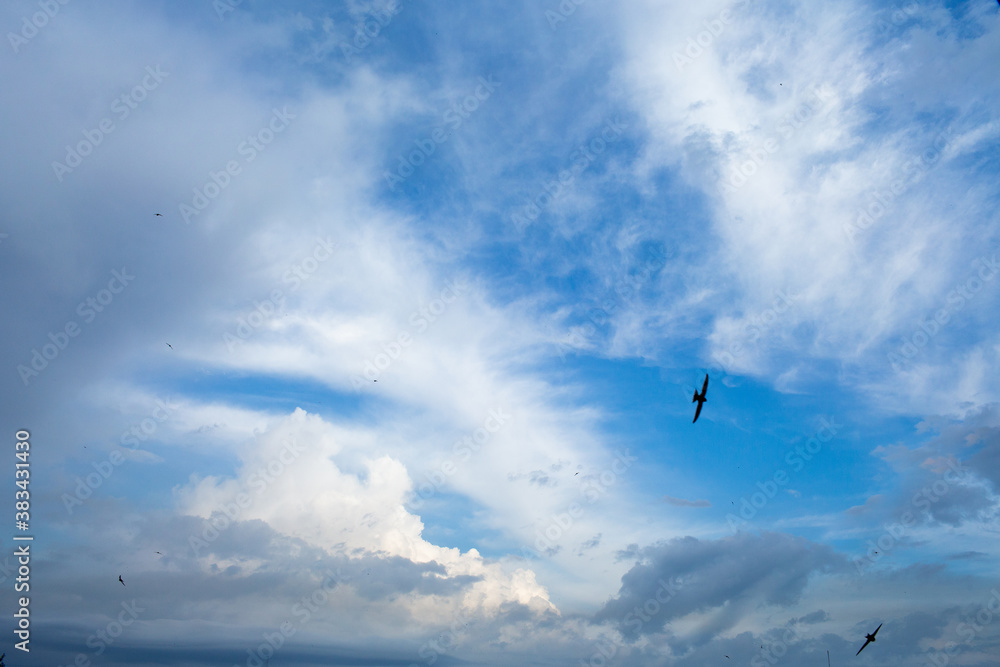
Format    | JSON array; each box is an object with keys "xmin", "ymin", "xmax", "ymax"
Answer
[{"xmin": 177, "ymin": 409, "xmax": 552, "ymax": 614}]
